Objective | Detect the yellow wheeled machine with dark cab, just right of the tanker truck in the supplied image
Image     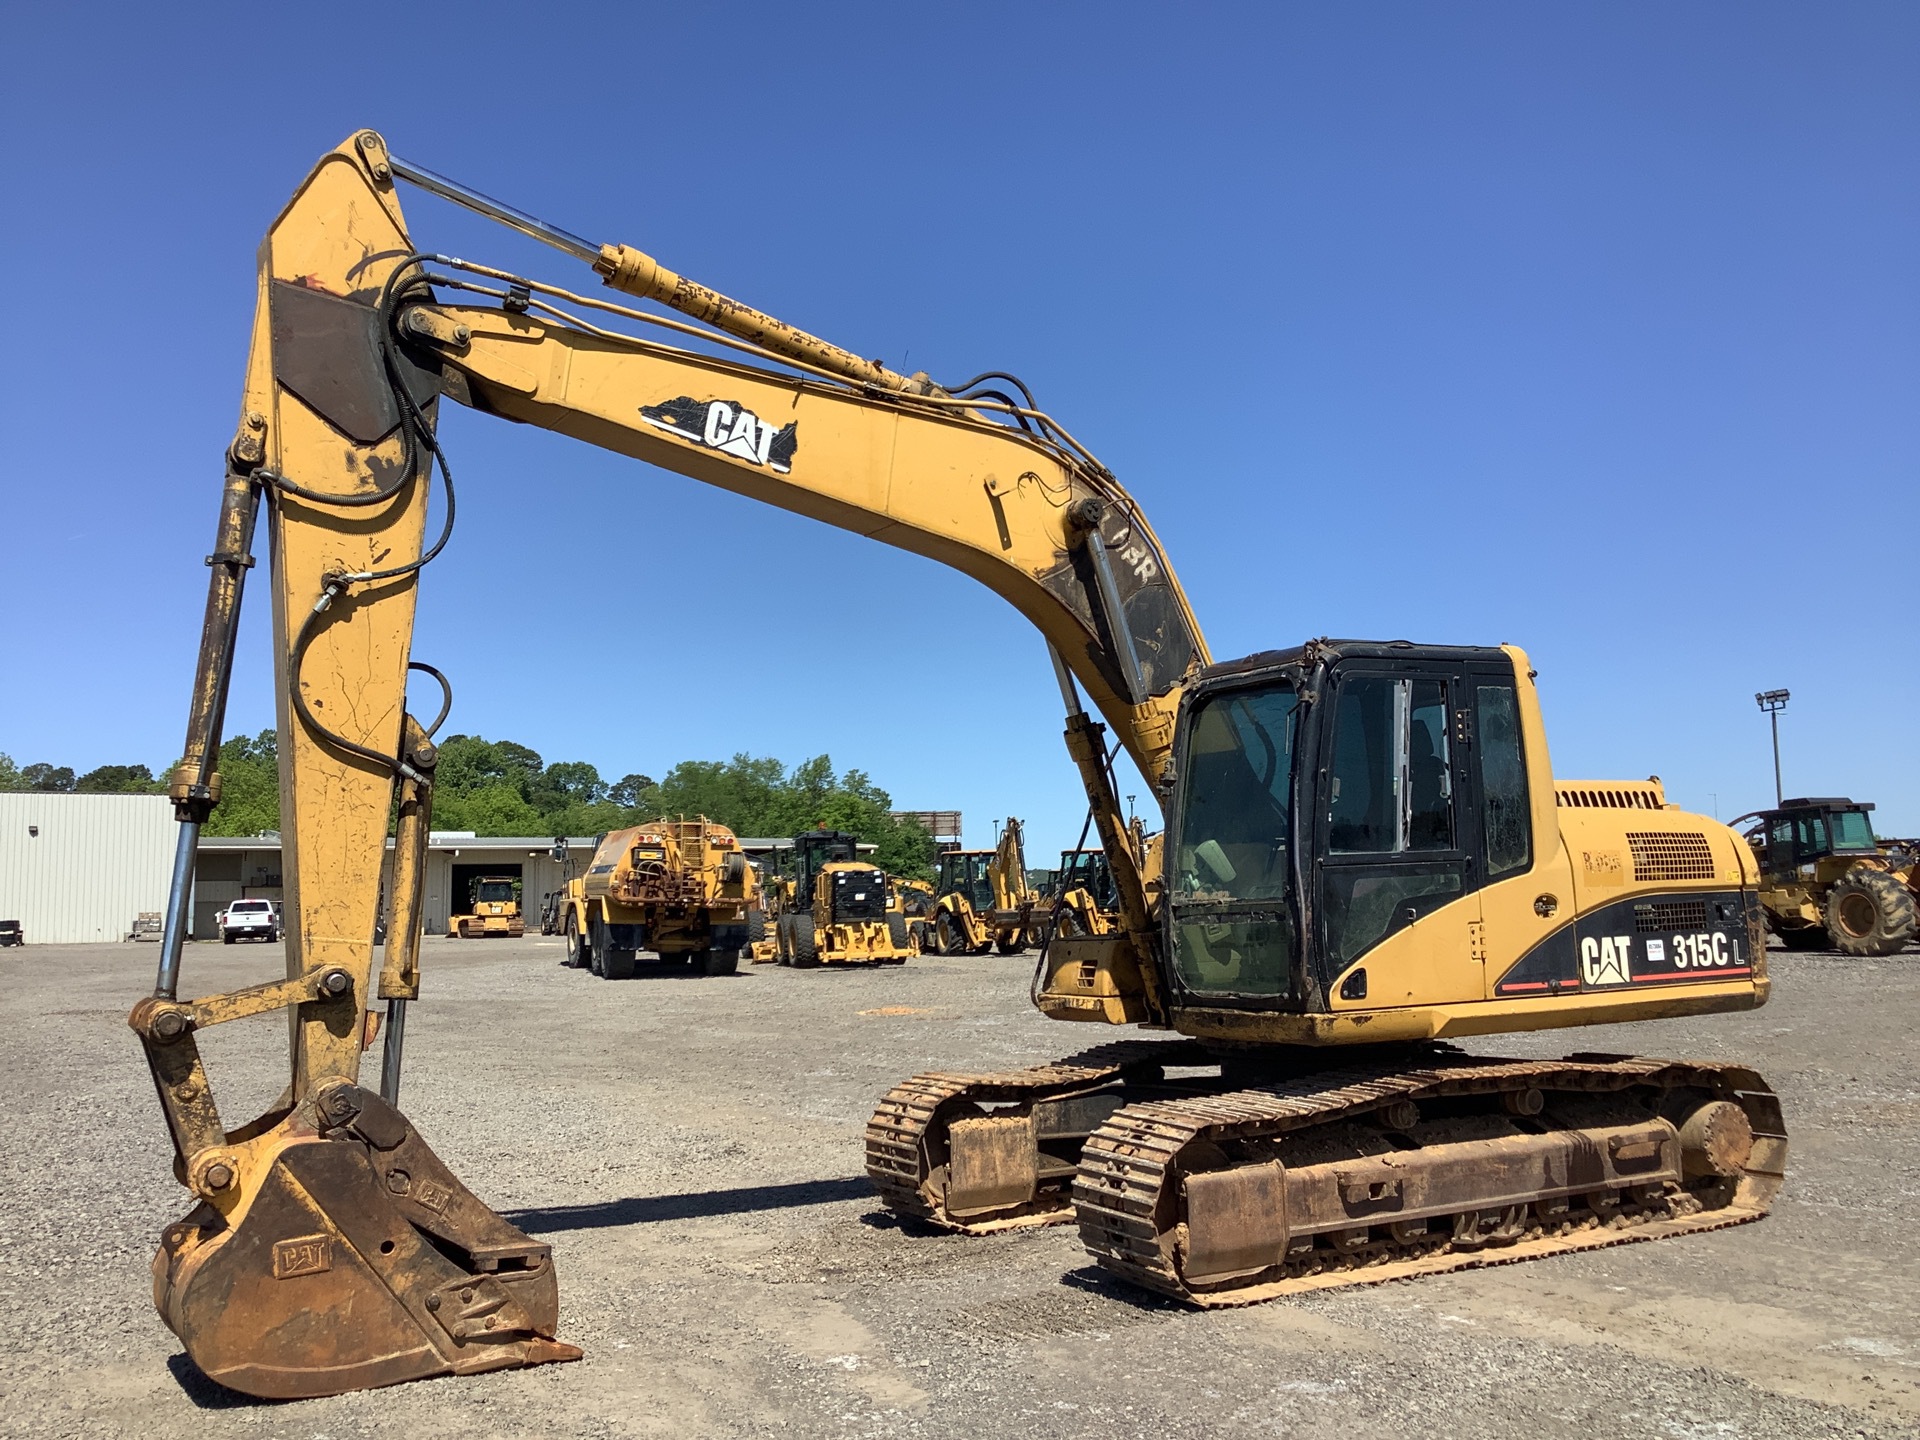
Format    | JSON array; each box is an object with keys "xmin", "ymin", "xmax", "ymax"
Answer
[{"xmin": 772, "ymin": 829, "xmax": 916, "ymax": 970}]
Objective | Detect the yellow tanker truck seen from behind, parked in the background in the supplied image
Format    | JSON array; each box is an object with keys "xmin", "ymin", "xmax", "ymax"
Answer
[{"xmin": 561, "ymin": 816, "xmax": 758, "ymax": 979}]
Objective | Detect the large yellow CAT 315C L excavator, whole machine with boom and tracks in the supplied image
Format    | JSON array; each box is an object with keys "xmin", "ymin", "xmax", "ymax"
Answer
[{"xmin": 131, "ymin": 131, "xmax": 1786, "ymax": 1396}]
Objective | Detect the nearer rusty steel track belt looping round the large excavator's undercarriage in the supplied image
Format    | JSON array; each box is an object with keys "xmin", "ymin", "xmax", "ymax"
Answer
[{"xmin": 1073, "ymin": 1056, "xmax": 1786, "ymax": 1306}]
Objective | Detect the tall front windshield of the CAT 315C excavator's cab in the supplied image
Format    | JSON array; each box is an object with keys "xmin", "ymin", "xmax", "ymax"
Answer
[{"xmin": 1167, "ymin": 684, "xmax": 1298, "ymax": 996}]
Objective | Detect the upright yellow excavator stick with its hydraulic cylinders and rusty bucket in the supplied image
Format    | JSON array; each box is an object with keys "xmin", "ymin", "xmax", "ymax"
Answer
[{"xmin": 129, "ymin": 136, "xmax": 580, "ymax": 1400}]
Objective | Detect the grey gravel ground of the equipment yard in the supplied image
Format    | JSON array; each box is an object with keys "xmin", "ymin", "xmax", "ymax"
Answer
[{"xmin": 0, "ymin": 937, "xmax": 1920, "ymax": 1440}]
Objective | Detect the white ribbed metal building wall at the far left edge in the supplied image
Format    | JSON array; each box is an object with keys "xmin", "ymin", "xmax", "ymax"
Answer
[{"xmin": 0, "ymin": 791, "xmax": 177, "ymax": 945}]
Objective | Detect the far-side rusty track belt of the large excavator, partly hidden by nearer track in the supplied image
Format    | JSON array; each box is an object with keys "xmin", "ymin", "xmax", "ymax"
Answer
[{"xmin": 866, "ymin": 1041, "xmax": 1208, "ymax": 1235}]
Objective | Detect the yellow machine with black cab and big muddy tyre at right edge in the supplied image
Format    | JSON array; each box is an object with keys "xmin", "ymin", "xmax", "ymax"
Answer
[{"xmin": 1730, "ymin": 797, "xmax": 1920, "ymax": 958}]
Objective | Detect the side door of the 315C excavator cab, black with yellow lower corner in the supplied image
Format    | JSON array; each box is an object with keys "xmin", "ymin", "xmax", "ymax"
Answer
[{"xmin": 1315, "ymin": 662, "xmax": 1484, "ymax": 1010}]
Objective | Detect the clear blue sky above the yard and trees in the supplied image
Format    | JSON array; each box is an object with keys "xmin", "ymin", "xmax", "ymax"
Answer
[{"xmin": 0, "ymin": 0, "xmax": 1920, "ymax": 851}]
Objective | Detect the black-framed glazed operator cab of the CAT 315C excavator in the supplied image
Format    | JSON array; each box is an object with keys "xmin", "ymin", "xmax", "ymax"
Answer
[{"xmin": 1165, "ymin": 643, "xmax": 1536, "ymax": 1010}]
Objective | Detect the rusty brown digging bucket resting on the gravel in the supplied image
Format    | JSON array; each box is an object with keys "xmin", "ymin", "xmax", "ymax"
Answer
[{"xmin": 154, "ymin": 1083, "xmax": 580, "ymax": 1400}]
